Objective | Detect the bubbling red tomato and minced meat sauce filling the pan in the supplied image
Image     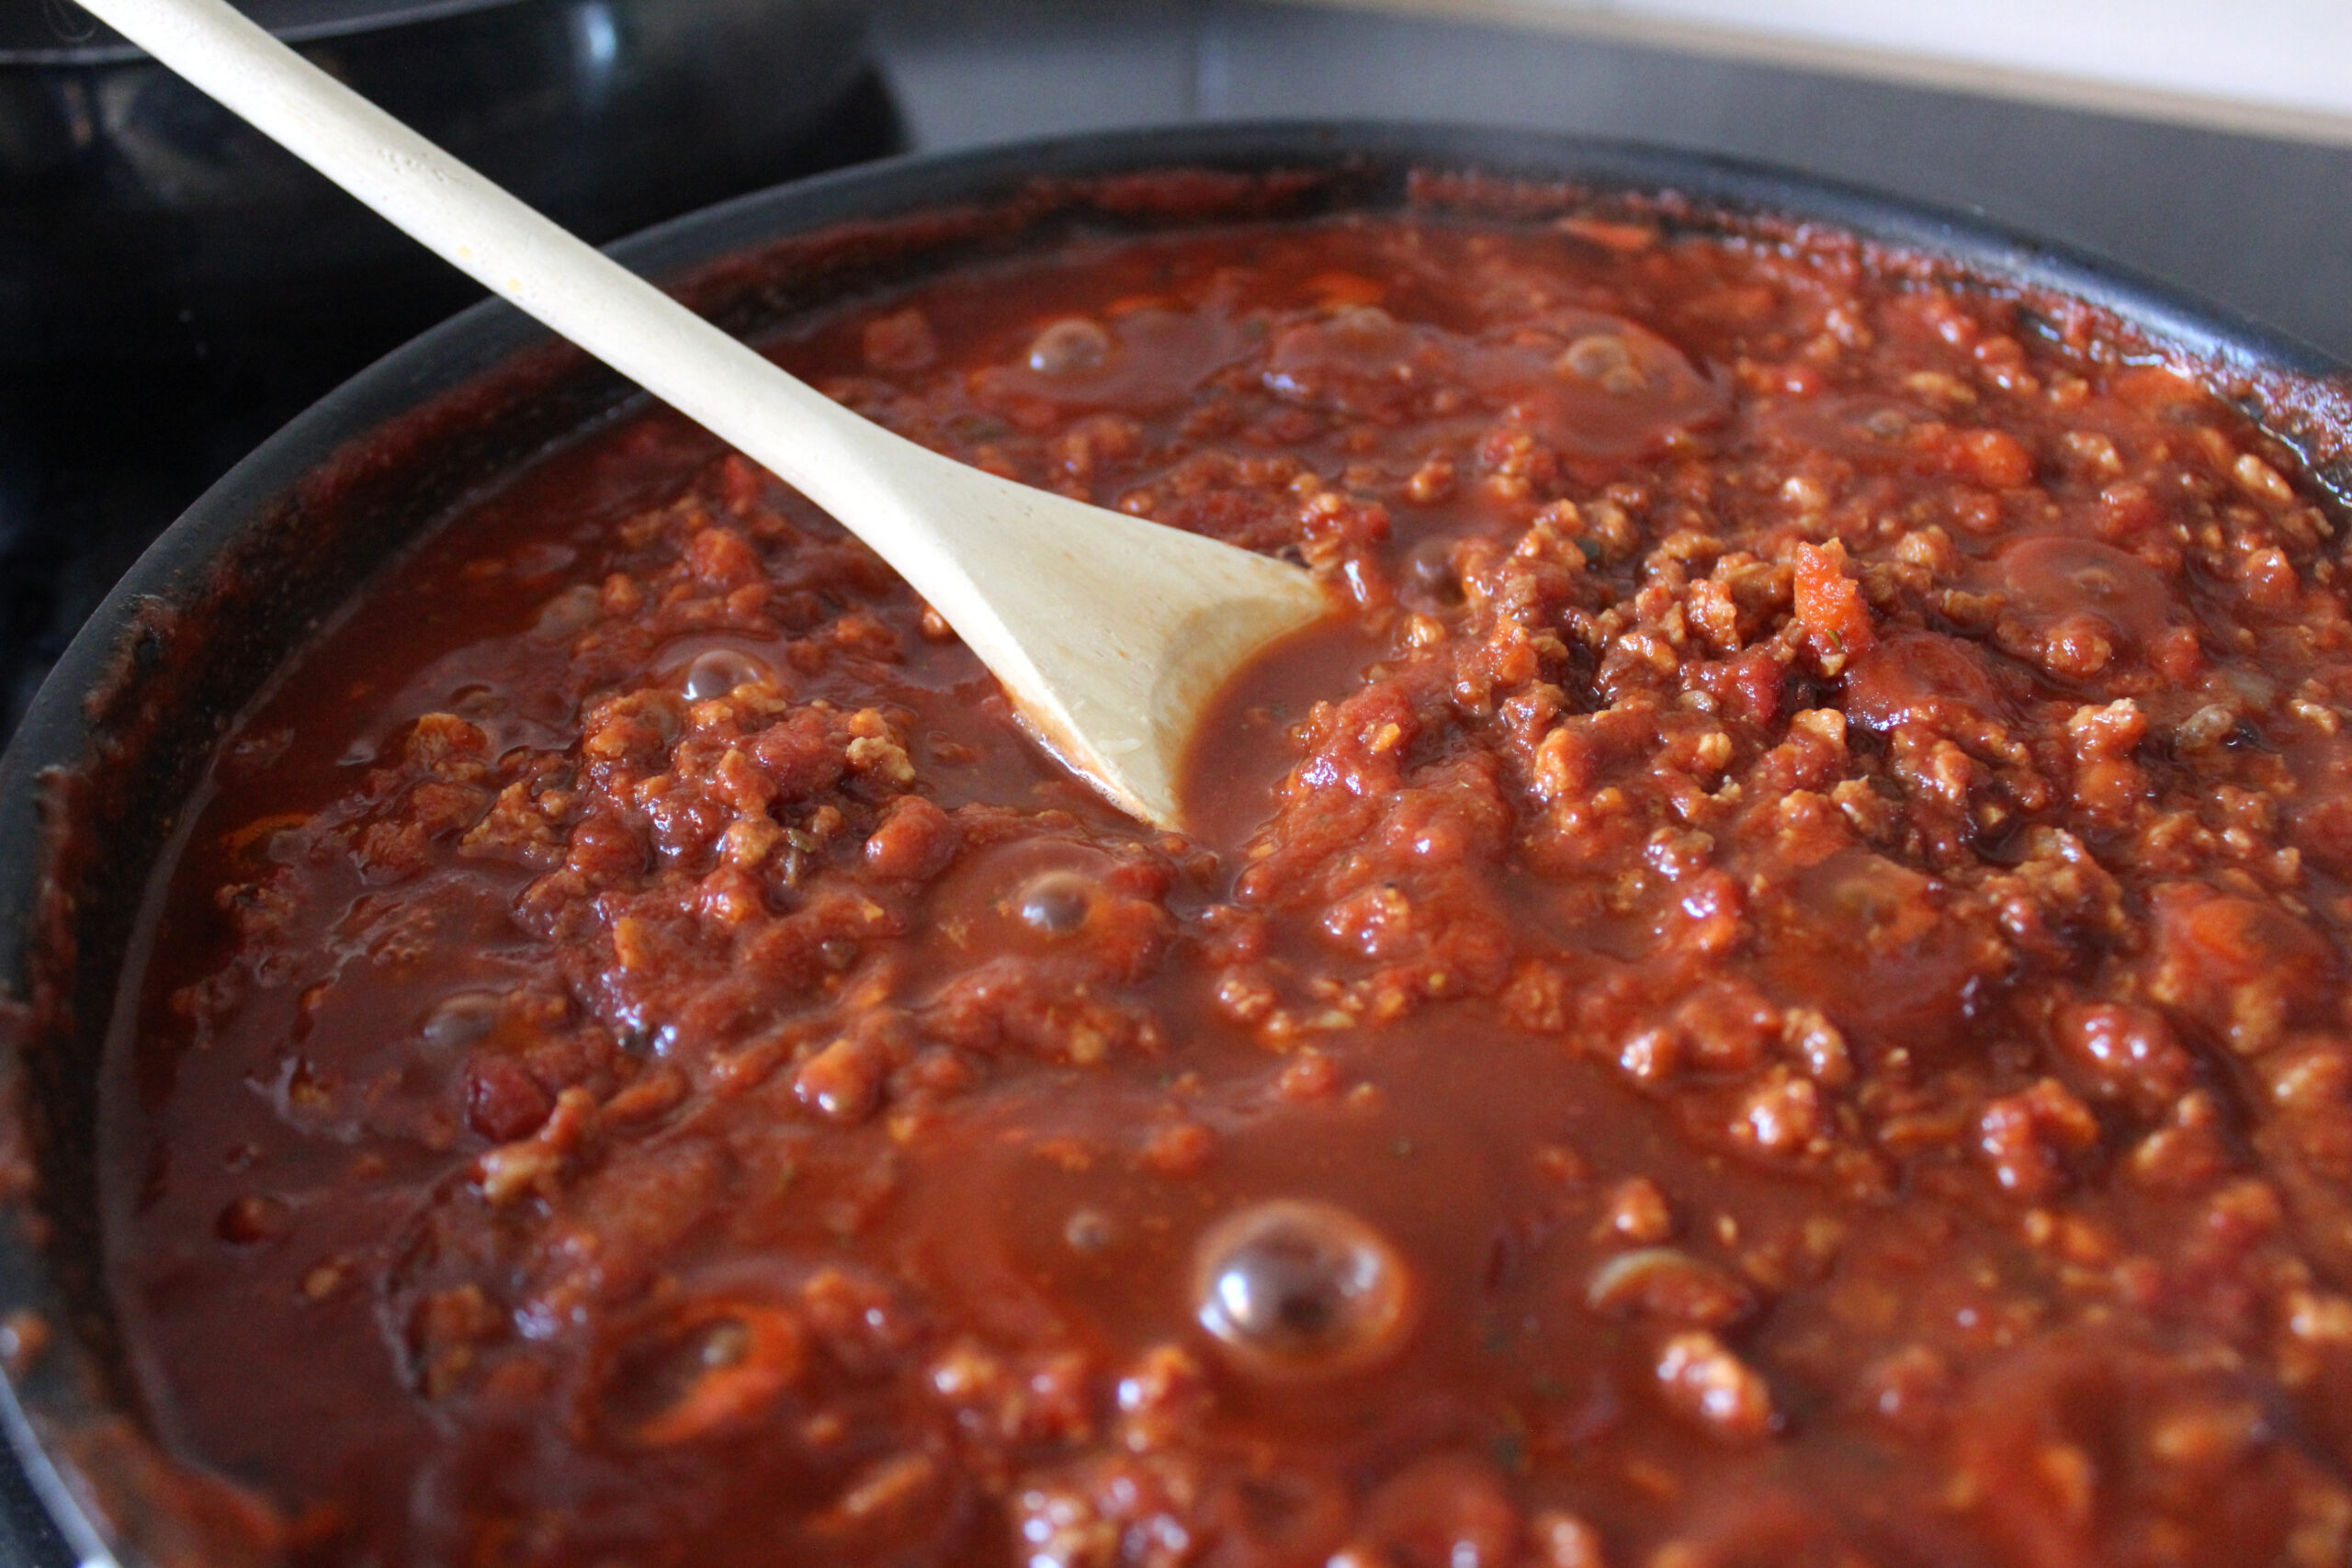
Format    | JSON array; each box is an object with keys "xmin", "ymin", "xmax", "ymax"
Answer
[{"xmin": 110, "ymin": 214, "xmax": 2352, "ymax": 1568}]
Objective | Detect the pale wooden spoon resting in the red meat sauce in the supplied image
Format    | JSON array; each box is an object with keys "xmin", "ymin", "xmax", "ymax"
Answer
[{"xmin": 85, "ymin": 0, "xmax": 1329, "ymax": 828}]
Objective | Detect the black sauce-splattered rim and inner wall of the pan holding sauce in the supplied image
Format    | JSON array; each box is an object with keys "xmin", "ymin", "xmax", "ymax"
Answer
[{"xmin": 0, "ymin": 125, "xmax": 2352, "ymax": 1568}]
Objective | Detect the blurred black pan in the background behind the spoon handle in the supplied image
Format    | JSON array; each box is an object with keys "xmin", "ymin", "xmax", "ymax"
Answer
[{"xmin": 0, "ymin": 0, "xmax": 865, "ymax": 365}]
